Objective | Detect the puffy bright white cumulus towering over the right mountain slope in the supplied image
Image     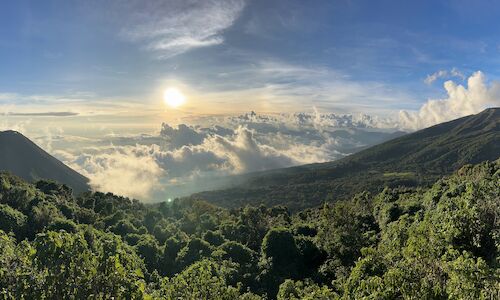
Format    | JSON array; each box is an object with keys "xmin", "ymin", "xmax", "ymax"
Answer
[{"xmin": 399, "ymin": 71, "xmax": 500, "ymax": 130}]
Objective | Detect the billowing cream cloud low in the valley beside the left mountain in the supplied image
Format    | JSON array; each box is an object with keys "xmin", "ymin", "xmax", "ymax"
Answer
[{"xmin": 57, "ymin": 127, "xmax": 302, "ymax": 201}]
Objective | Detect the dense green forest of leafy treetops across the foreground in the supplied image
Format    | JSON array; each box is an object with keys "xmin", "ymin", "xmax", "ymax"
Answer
[{"xmin": 0, "ymin": 160, "xmax": 500, "ymax": 299}]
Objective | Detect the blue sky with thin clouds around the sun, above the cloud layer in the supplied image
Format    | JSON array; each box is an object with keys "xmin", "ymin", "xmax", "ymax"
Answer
[{"xmin": 0, "ymin": 0, "xmax": 500, "ymax": 122}]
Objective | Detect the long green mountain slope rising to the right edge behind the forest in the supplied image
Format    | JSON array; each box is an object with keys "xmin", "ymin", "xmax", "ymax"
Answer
[{"xmin": 192, "ymin": 108, "xmax": 500, "ymax": 210}]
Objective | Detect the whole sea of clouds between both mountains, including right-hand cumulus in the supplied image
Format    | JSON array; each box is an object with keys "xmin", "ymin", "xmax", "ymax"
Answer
[{"xmin": 24, "ymin": 72, "xmax": 500, "ymax": 201}]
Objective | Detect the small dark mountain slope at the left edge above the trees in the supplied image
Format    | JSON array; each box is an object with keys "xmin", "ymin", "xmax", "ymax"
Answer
[{"xmin": 0, "ymin": 130, "xmax": 89, "ymax": 193}]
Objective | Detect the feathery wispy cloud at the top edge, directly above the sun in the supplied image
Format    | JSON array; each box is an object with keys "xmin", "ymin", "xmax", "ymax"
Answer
[{"xmin": 122, "ymin": 0, "xmax": 245, "ymax": 58}]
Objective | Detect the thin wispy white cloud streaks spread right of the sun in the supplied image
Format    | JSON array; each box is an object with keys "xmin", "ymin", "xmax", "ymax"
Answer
[{"xmin": 197, "ymin": 59, "xmax": 415, "ymax": 113}]
